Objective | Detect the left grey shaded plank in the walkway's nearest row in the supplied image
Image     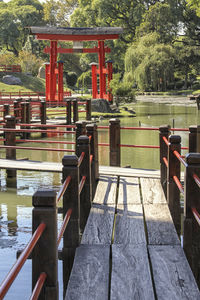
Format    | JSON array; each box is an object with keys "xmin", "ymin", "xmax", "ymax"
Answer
[{"xmin": 65, "ymin": 245, "xmax": 110, "ymax": 300}]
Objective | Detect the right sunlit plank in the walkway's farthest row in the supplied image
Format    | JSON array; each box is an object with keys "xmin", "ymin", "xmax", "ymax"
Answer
[{"xmin": 140, "ymin": 178, "xmax": 166, "ymax": 204}]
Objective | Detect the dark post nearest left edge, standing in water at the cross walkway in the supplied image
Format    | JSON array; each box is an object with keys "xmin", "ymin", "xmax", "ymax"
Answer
[{"xmin": 5, "ymin": 116, "xmax": 16, "ymax": 178}]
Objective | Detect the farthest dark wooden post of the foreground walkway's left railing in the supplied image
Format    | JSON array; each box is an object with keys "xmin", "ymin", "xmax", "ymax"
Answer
[{"xmin": 86, "ymin": 124, "xmax": 99, "ymax": 199}]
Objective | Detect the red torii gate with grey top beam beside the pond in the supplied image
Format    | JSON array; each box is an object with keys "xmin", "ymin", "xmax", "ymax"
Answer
[{"xmin": 30, "ymin": 27, "xmax": 122, "ymax": 102}]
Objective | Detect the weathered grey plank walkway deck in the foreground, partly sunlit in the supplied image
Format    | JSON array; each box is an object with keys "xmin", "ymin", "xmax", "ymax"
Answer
[{"xmin": 65, "ymin": 175, "xmax": 200, "ymax": 300}]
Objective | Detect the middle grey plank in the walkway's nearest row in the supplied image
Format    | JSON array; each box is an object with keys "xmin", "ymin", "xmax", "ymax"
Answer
[{"xmin": 111, "ymin": 245, "xmax": 155, "ymax": 300}]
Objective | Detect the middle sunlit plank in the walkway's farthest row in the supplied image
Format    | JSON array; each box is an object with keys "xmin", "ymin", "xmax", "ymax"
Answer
[{"xmin": 118, "ymin": 177, "xmax": 141, "ymax": 205}]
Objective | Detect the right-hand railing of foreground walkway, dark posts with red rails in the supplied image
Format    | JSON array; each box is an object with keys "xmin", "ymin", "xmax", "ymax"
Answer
[{"xmin": 160, "ymin": 126, "xmax": 200, "ymax": 283}]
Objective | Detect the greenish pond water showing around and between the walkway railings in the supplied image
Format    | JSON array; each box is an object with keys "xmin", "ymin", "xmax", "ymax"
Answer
[{"xmin": 0, "ymin": 97, "xmax": 199, "ymax": 300}]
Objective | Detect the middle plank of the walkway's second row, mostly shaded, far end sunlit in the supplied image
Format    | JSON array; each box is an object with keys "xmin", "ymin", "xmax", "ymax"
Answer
[{"xmin": 114, "ymin": 204, "xmax": 146, "ymax": 245}]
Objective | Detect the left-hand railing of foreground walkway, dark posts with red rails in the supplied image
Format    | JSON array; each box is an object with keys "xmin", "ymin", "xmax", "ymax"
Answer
[{"xmin": 0, "ymin": 131, "xmax": 98, "ymax": 300}]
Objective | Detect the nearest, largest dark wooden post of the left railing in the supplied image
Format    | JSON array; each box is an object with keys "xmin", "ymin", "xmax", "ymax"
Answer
[{"xmin": 32, "ymin": 189, "xmax": 58, "ymax": 300}]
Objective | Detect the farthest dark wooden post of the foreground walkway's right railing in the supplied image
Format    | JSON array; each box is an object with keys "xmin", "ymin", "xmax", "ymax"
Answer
[{"xmin": 159, "ymin": 125, "xmax": 170, "ymax": 198}]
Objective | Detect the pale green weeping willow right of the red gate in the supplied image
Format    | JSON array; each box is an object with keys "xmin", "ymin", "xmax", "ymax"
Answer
[{"xmin": 124, "ymin": 33, "xmax": 175, "ymax": 91}]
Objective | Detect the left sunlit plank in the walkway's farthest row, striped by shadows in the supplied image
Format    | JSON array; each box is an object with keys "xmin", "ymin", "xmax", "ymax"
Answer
[{"xmin": 93, "ymin": 176, "xmax": 117, "ymax": 205}]
